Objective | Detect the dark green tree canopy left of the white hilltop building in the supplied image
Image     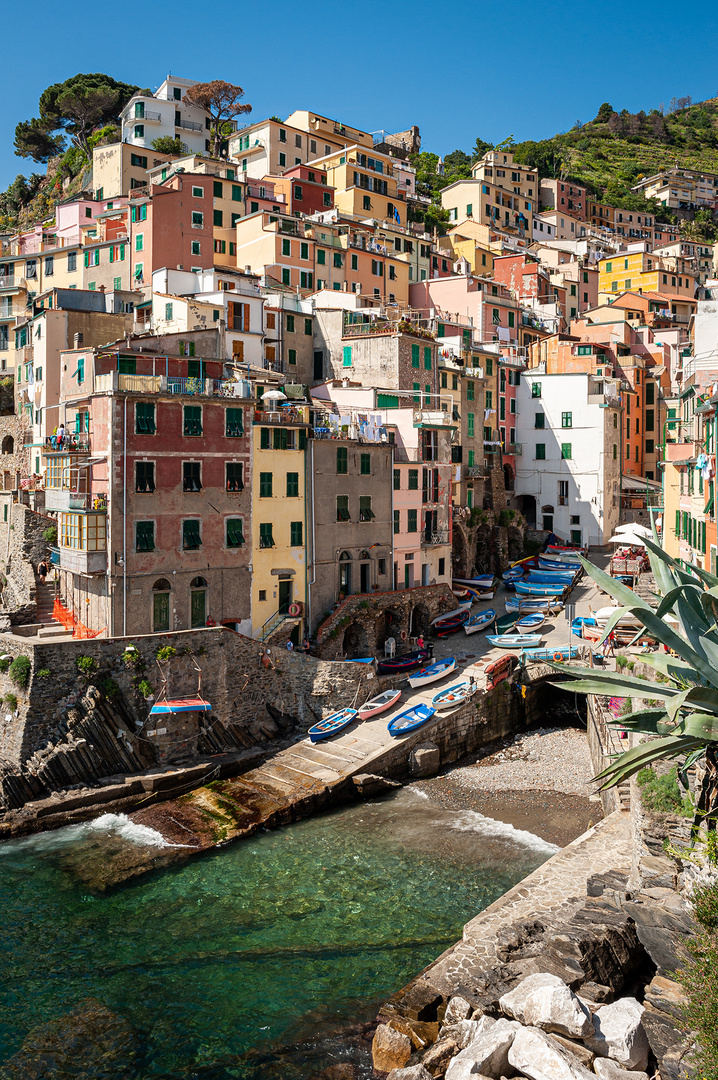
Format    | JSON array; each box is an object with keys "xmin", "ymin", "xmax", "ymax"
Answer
[{"xmin": 15, "ymin": 72, "xmax": 140, "ymax": 162}]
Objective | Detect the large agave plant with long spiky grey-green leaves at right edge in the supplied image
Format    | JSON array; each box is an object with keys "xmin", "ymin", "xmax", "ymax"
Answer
[{"xmin": 552, "ymin": 534, "xmax": 718, "ymax": 828}]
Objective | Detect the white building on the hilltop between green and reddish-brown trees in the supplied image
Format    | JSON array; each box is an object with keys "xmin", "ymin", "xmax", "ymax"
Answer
[{"xmin": 120, "ymin": 76, "xmax": 211, "ymax": 154}]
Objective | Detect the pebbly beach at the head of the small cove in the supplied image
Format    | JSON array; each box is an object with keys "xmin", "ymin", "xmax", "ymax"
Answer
[{"xmin": 412, "ymin": 727, "xmax": 602, "ymax": 847}]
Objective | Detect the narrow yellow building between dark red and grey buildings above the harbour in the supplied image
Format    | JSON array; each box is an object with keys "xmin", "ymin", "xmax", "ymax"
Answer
[{"xmin": 252, "ymin": 406, "xmax": 309, "ymax": 644}]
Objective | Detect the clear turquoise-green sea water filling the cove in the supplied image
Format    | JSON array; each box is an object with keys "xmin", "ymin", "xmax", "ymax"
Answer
[{"xmin": 0, "ymin": 788, "xmax": 555, "ymax": 1080}]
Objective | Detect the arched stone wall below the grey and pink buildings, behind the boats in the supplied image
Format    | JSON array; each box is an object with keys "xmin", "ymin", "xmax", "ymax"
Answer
[{"xmin": 316, "ymin": 584, "xmax": 458, "ymax": 660}]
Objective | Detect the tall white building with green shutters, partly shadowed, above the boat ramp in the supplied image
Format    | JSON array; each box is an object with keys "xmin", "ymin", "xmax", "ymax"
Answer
[{"xmin": 516, "ymin": 366, "xmax": 622, "ymax": 545}]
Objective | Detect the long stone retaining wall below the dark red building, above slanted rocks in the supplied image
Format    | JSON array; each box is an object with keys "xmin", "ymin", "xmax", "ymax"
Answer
[{"xmin": 0, "ymin": 626, "xmax": 367, "ymax": 766}]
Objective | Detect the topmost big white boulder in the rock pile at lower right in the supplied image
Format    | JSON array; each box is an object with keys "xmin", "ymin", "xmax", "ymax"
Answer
[{"xmin": 499, "ymin": 972, "xmax": 594, "ymax": 1039}]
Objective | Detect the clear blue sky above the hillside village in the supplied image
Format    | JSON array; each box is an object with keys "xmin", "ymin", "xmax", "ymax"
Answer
[{"xmin": 0, "ymin": 0, "xmax": 718, "ymax": 189}]
